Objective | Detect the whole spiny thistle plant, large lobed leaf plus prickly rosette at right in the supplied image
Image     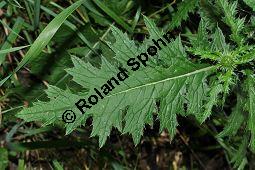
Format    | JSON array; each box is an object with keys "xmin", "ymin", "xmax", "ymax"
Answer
[{"xmin": 15, "ymin": 0, "xmax": 255, "ymax": 161}]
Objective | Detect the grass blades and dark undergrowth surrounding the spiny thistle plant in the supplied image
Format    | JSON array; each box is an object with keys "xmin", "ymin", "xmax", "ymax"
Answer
[{"xmin": 0, "ymin": 0, "xmax": 255, "ymax": 170}]
